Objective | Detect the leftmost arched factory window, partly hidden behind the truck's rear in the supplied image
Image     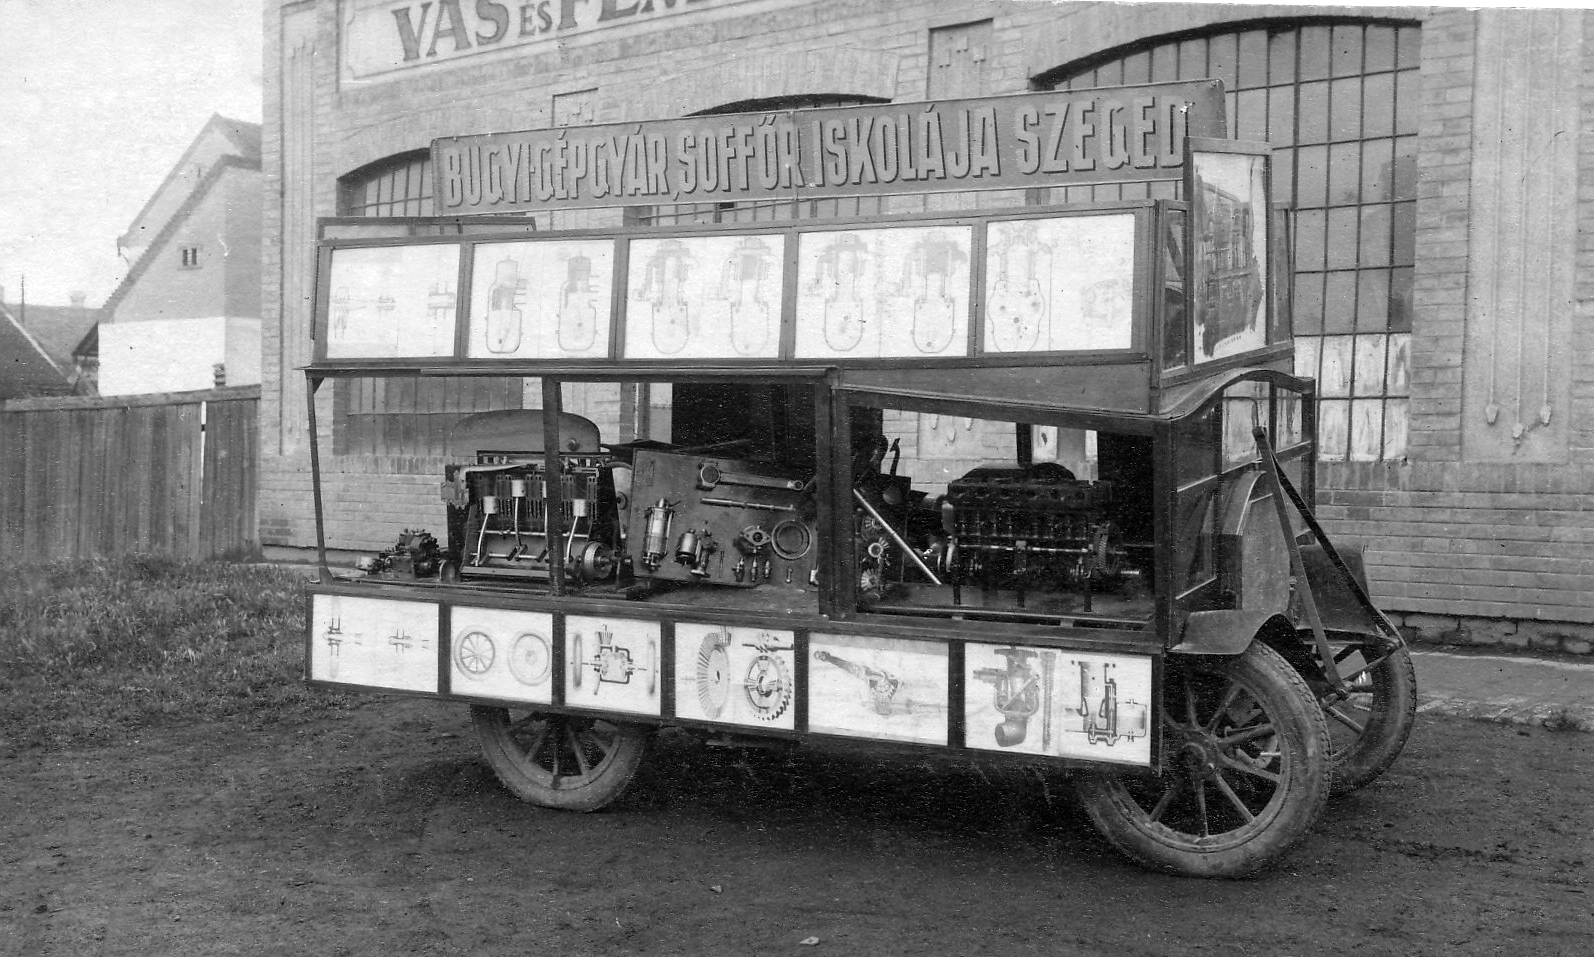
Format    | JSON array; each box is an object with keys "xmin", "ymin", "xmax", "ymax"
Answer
[{"xmin": 332, "ymin": 150, "xmax": 524, "ymax": 456}]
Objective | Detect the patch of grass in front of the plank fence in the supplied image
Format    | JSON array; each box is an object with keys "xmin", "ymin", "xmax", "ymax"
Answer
[{"xmin": 0, "ymin": 557, "xmax": 350, "ymax": 746}]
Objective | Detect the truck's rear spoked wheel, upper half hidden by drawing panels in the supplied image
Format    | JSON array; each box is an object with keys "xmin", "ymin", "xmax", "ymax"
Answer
[{"xmin": 470, "ymin": 707, "xmax": 649, "ymax": 810}]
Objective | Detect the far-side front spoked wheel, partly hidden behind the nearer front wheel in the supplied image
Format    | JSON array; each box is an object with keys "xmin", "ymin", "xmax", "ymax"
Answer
[{"xmin": 1317, "ymin": 644, "xmax": 1417, "ymax": 794}]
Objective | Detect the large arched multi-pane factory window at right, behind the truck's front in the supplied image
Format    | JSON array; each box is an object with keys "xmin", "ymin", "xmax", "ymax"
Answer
[{"xmin": 1039, "ymin": 19, "xmax": 1422, "ymax": 461}]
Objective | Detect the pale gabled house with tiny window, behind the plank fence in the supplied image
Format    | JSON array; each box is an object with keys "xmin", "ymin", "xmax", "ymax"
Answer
[{"xmin": 96, "ymin": 115, "xmax": 261, "ymax": 396}]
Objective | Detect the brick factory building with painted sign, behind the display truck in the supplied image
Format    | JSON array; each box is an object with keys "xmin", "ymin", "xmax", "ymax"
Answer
[{"xmin": 258, "ymin": 0, "xmax": 1594, "ymax": 652}]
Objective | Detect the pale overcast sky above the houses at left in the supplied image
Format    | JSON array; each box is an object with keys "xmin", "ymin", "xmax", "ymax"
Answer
[{"xmin": 0, "ymin": 0, "xmax": 263, "ymax": 306}]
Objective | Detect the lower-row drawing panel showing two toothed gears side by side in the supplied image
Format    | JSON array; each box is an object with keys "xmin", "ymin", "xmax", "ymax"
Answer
[{"xmin": 676, "ymin": 622, "xmax": 797, "ymax": 731}]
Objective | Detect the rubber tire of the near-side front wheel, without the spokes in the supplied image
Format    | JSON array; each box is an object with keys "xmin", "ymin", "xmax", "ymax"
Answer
[{"xmin": 1074, "ymin": 641, "xmax": 1333, "ymax": 877}]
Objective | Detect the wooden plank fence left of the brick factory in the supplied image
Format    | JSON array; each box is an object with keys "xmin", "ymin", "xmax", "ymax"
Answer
[{"xmin": 0, "ymin": 386, "xmax": 260, "ymax": 561}]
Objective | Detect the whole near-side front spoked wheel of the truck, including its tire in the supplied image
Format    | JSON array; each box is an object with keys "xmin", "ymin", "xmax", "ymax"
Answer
[{"xmin": 1074, "ymin": 641, "xmax": 1331, "ymax": 877}]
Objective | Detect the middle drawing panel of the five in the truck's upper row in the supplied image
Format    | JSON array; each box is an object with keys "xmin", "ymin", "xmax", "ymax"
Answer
[{"xmin": 625, "ymin": 234, "xmax": 786, "ymax": 359}]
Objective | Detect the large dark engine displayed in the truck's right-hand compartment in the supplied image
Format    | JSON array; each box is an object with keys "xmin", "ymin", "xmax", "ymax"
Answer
[{"xmin": 942, "ymin": 464, "xmax": 1140, "ymax": 611}]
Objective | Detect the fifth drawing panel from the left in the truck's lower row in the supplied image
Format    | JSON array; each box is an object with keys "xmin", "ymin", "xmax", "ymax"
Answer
[{"xmin": 808, "ymin": 635, "xmax": 950, "ymax": 745}]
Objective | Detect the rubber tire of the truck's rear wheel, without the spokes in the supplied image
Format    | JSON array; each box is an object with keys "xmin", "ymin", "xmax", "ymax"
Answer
[{"xmin": 470, "ymin": 705, "xmax": 652, "ymax": 812}]
